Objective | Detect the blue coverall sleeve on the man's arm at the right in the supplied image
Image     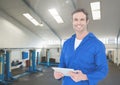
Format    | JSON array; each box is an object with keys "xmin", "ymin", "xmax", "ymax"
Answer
[{"xmin": 87, "ymin": 45, "xmax": 108, "ymax": 85}]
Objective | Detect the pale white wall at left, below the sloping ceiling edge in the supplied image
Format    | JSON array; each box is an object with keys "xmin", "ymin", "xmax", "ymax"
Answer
[{"xmin": 0, "ymin": 11, "xmax": 41, "ymax": 48}]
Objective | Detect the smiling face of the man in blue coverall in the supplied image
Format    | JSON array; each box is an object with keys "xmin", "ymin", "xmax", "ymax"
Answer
[{"xmin": 73, "ymin": 12, "xmax": 88, "ymax": 32}]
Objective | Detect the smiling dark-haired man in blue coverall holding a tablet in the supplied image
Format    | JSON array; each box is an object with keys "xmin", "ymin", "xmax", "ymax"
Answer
[{"xmin": 54, "ymin": 9, "xmax": 108, "ymax": 85}]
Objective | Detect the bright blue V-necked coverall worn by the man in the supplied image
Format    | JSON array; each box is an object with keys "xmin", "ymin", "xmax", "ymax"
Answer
[{"xmin": 59, "ymin": 32, "xmax": 108, "ymax": 85}]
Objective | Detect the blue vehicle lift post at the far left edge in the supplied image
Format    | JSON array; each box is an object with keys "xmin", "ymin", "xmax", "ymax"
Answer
[{"xmin": 0, "ymin": 50, "xmax": 11, "ymax": 85}]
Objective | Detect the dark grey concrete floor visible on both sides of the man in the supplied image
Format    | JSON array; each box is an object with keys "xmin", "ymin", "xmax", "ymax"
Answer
[{"xmin": 1, "ymin": 63, "xmax": 120, "ymax": 85}]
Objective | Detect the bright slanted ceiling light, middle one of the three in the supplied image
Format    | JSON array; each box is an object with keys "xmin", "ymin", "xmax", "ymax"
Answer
[{"xmin": 48, "ymin": 8, "xmax": 64, "ymax": 23}]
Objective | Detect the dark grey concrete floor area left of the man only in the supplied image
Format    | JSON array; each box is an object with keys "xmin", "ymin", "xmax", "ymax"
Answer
[{"xmin": 11, "ymin": 67, "xmax": 61, "ymax": 85}]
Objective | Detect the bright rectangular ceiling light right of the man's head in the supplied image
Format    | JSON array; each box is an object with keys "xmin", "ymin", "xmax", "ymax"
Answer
[{"xmin": 90, "ymin": 1, "xmax": 101, "ymax": 20}]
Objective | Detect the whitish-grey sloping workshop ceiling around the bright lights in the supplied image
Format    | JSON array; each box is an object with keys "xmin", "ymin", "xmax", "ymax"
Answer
[{"xmin": 0, "ymin": 0, "xmax": 120, "ymax": 43}]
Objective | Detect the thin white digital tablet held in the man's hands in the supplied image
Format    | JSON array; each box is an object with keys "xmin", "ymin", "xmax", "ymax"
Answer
[{"xmin": 52, "ymin": 67, "xmax": 74, "ymax": 76}]
